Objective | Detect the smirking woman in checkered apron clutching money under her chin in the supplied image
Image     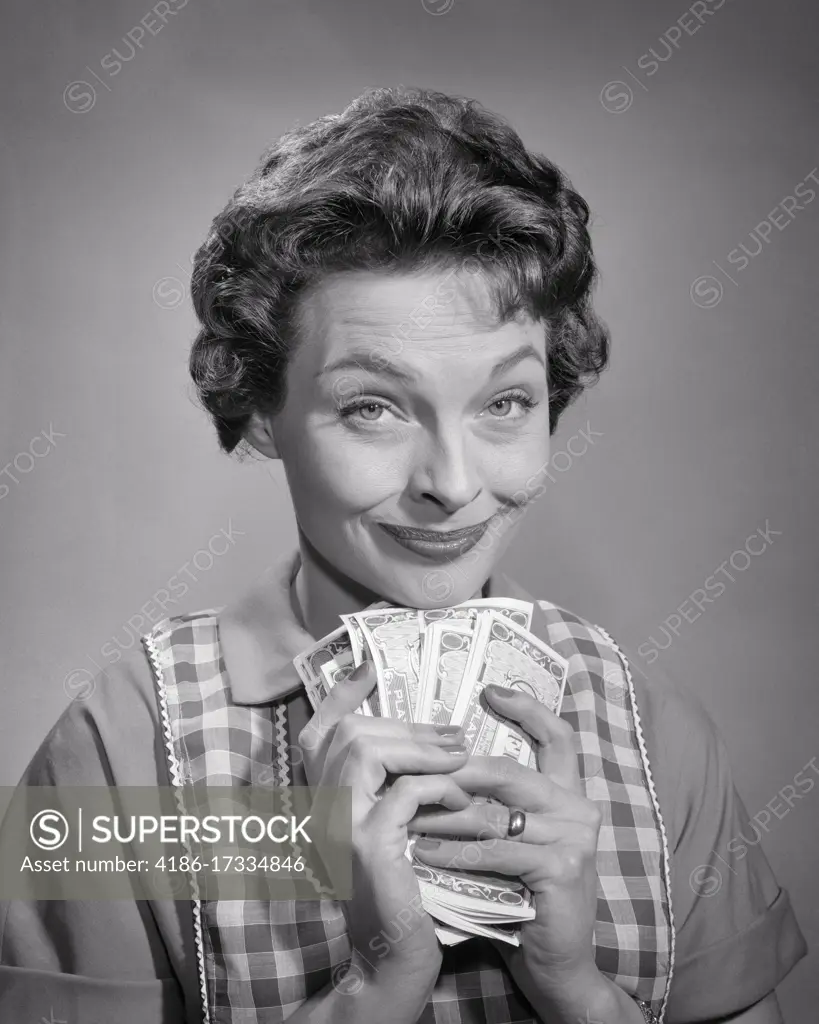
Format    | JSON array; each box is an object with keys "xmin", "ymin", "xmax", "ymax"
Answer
[{"xmin": 0, "ymin": 83, "xmax": 806, "ymax": 1024}]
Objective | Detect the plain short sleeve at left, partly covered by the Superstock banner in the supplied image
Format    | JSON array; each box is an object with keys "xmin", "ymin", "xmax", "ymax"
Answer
[{"xmin": 0, "ymin": 655, "xmax": 195, "ymax": 1024}]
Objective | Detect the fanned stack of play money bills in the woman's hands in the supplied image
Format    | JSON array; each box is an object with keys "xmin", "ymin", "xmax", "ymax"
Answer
[{"xmin": 293, "ymin": 598, "xmax": 568, "ymax": 945}]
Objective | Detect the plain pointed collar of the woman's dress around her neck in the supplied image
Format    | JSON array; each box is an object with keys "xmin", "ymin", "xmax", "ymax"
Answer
[{"xmin": 219, "ymin": 549, "xmax": 547, "ymax": 705}]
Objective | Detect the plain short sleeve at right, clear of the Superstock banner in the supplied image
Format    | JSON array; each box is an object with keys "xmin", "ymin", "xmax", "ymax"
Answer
[{"xmin": 635, "ymin": 674, "xmax": 807, "ymax": 1024}]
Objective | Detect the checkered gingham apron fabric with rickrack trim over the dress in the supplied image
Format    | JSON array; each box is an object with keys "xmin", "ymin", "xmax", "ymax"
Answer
[{"xmin": 142, "ymin": 601, "xmax": 674, "ymax": 1024}]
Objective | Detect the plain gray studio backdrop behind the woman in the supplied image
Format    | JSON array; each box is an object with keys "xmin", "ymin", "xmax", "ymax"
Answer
[{"xmin": 0, "ymin": 0, "xmax": 819, "ymax": 1022}]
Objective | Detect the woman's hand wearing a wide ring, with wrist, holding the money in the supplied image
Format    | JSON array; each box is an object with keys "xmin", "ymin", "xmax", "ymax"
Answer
[{"xmin": 410, "ymin": 686, "xmax": 607, "ymax": 1020}]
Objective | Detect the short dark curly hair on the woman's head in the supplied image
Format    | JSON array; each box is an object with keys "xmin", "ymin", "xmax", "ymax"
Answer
[{"xmin": 189, "ymin": 87, "xmax": 609, "ymax": 452}]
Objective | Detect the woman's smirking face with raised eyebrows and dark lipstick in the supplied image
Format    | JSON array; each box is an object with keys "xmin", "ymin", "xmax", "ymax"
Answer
[{"xmin": 254, "ymin": 269, "xmax": 549, "ymax": 607}]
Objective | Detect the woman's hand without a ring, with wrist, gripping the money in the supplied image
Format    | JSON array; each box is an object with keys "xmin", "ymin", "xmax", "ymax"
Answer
[{"xmin": 299, "ymin": 663, "xmax": 470, "ymax": 1022}]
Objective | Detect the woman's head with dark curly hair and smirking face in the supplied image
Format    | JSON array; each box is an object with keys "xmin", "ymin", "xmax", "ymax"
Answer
[{"xmin": 190, "ymin": 83, "xmax": 608, "ymax": 629}]
